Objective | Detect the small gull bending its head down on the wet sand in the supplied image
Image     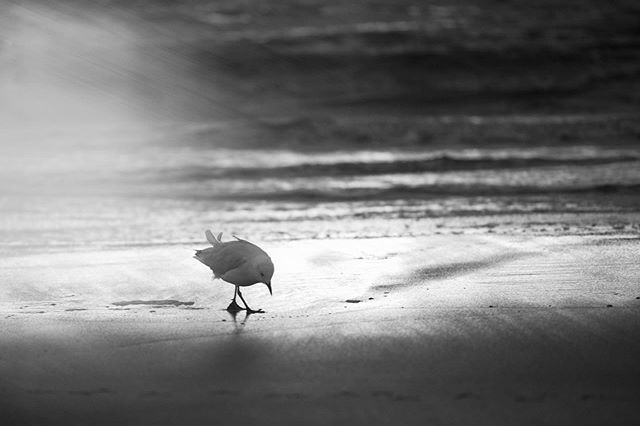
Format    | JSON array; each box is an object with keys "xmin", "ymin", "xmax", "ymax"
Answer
[{"xmin": 193, "ymin": 229, "xmax": 274, "ymax": 313}]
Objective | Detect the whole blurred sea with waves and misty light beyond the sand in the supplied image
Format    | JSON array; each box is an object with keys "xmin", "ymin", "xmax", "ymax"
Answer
[{"xmin": 0, "ymin": 0, "xmax": 640, "ymax": 254}]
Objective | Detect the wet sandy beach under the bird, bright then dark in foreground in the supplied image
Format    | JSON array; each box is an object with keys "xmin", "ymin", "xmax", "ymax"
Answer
[{"xmin": 0, "ymin": 234, "xmax": 640, "ymax": 425}]
